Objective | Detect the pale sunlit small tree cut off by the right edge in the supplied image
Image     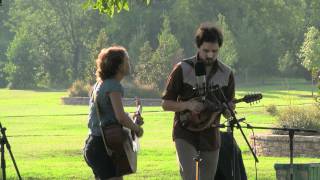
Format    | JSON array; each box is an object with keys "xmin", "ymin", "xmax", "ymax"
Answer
[{"xmin": 300, "ymin": 27, "xmax": 320, "ymax": 77}]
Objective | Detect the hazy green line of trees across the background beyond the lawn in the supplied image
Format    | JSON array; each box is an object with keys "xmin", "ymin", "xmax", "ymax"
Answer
[{"xmin": 0, "ymin": 0, "xmax": 320, "ymax": 90}]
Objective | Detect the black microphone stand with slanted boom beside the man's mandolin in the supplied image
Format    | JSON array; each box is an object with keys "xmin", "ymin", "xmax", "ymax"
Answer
[{"xmin": 216, "ymin": 86, "xmax": 259, "ymax": 180}]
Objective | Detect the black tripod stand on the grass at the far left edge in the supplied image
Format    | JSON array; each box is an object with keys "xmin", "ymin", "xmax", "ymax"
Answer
[{"xmin": 0, "ymin": 123, "xmax": 22, "ymax": 180}]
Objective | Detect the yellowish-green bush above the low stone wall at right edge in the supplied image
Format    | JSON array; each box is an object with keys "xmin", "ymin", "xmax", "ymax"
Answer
[{"xmin": 274, "ymin": 105, "xmax": 320, "ymax": 134}]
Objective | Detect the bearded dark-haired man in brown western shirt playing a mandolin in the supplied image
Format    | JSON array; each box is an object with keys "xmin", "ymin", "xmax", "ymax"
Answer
[{"xmin": 162, "ymin": 23, "xmax": 235, "ymax": 180}]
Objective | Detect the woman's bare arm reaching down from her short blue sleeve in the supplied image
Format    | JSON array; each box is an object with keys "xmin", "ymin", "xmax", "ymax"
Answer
[{"xmin": 109, "ymin": 92, "xmax": 143, "ymax": 137}]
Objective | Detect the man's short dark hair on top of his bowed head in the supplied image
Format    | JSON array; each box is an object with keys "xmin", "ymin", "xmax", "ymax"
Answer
[{"xmin": 196, "ymin": 22, "xmax": 223, "ymax": 48}]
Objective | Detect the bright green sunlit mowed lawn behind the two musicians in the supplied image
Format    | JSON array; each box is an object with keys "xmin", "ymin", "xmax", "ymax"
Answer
[{"xmin": 0, "ymin": 80, "xmax": 320, "ymax": 180}]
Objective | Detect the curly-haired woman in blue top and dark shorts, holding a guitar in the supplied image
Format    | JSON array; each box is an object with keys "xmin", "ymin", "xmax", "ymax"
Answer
[{"xmin": 84, "ymin": 46, "xmax": 143, "ymax": 180}]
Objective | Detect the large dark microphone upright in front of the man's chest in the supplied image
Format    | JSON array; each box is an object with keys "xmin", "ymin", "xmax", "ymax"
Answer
[{"xmin": 194, "ymin": 62, "xmax": 207, "ymax": 101}]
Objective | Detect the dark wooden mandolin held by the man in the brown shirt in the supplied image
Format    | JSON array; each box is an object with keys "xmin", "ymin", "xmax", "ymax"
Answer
[{"xmin": 179, "ymin": 93, "xmax": 262, "ymax": 131}]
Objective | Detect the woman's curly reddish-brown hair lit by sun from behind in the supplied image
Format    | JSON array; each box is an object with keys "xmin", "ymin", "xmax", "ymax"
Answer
[{"xmin": 96, "ymin": 46, "xmax": 128, "ymax": 81}]
